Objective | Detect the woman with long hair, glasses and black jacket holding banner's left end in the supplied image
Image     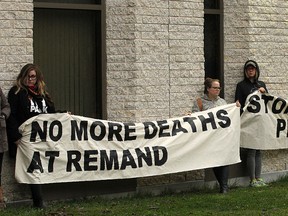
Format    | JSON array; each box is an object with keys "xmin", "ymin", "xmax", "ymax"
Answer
[{"xmin": 7, "ymin": 63, "xmax": 55, "ymax": 208}]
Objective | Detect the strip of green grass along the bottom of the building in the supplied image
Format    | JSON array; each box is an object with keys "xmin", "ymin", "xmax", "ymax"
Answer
[{"xmin": 0, "ymin": 177, "xmax": 288, "ymax": 216}]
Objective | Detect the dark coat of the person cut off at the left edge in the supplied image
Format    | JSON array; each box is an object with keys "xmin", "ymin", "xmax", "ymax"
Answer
[{"xmin": 0, "ymin": 88, "xmax": 11, "ymax": 152}]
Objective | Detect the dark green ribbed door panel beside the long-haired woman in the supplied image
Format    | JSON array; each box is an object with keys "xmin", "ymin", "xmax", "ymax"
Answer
[{"xmin": 34, "ymin": 8, "xmax": 103, "ymax": 119}]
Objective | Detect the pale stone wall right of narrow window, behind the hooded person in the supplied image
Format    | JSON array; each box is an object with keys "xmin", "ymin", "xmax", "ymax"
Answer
[{"xmin": 224, "ymin": 0, "xmax": 288, "ymax": 172}]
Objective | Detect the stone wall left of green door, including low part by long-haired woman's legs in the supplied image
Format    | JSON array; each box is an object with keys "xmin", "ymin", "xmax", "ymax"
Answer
[{"xmin": 0, "ymin": 0, "xmax": 33, "ymax": 201}]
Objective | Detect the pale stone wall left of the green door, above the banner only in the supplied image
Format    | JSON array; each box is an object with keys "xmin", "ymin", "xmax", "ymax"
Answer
[{"xmin": 0, "ymin": 0, "xmax": 33, "ymax": 92}]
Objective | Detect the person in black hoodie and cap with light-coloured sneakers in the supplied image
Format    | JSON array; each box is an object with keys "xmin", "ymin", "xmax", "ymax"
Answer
[{"xmin": 235, "ymin": 60, "xmax": 268, "ymax": 187}]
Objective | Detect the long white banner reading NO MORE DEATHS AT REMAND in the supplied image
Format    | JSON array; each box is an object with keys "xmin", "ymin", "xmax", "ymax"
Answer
[{"xmin": 15, "ymin": 104, "xmax": 240, "ymax": 184}]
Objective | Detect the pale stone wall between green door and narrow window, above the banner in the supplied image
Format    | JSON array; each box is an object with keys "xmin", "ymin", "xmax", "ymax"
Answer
[{"xmin": 106, "ymin": 0, "xmax": 204, "ymax": 121}]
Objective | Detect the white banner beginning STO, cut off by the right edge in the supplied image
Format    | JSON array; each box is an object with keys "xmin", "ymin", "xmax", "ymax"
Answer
[{"xmin": 240, "ymin": 92, "xmax": 288, "ymax": 150}]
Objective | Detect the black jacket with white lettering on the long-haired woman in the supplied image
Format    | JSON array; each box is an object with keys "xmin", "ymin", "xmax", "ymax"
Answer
[{"xmin": 7, "ymin": 86, "xmax": 55, "ymax": 157}]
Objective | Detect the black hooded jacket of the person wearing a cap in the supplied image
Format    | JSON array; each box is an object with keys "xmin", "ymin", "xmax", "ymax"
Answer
[{"xmin": 235, "ymin": 60, "xmax": 268, "ymax": 114}]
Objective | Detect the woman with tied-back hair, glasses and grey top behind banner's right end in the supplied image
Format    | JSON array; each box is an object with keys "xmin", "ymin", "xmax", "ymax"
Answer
[{"xmin": 192, "ymin": 78, "xmax": 240, "ymax": 193}]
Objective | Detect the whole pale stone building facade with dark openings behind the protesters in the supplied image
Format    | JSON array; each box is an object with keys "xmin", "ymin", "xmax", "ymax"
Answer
[{"xmin": 0, "ymin": 0, "xmax": 288, "ymax": 201}]
